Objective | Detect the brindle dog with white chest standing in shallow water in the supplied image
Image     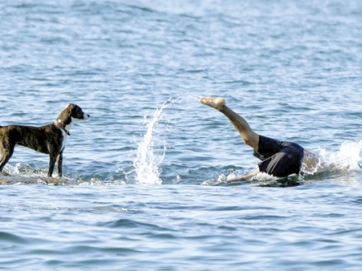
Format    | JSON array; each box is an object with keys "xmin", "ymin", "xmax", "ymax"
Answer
[{"xmin": 0, "ymin": 104, "xmax": 90, "ymax": 177}]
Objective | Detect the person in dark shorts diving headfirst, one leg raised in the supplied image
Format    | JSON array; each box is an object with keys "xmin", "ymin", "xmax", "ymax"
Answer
[{"xmin": 200, "ymin": 97, "xmax": 329, "ymax": 181}]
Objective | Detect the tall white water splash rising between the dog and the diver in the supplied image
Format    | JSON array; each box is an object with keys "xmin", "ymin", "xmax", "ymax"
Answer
[{"xmin": 133, "ymin": 98, "xmax": 174, "ymax": 184}]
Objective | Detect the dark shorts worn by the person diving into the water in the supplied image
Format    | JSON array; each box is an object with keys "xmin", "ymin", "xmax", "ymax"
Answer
[{"xmin": 254, "ymin": 136, "xmax": 304, "ymax": 177}]
